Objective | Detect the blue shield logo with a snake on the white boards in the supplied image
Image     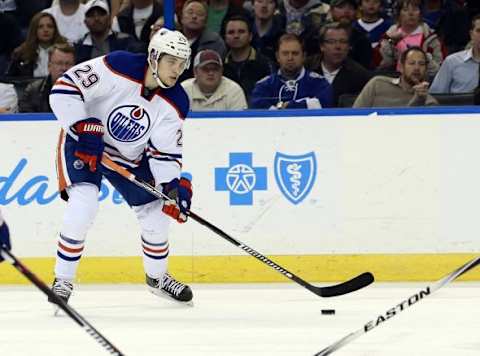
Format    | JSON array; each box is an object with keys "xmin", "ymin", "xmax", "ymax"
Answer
[{"xmin": 274, "ymin": 152, "xmax": 317, "ymax": 204}]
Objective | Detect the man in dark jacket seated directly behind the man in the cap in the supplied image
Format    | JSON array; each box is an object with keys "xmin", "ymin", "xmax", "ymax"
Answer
[{"xmin": 179, "ymin": 0, "xmax": 227, "ymax": 81}]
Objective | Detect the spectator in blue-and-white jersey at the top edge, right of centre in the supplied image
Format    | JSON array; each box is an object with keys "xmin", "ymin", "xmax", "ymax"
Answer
[{"xmin": 353, "ymin": 0, "xmax": 392, "ymax": 51}]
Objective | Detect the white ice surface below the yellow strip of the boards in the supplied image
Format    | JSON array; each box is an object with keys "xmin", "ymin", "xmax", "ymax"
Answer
[{"xmin": 0, "ymin": 282, "xmax": 480, "ymax": 356}]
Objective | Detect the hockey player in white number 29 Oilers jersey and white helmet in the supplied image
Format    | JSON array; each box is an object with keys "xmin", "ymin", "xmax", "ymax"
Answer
[{"xmin": 50, "ymin": 29, "xmax": 193, "ymax": 302}]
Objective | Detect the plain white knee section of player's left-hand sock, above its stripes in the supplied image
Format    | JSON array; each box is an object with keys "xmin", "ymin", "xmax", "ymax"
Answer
[{"xmin": 61, "ymin": 183, "xmax": 98, "ymax": 240}]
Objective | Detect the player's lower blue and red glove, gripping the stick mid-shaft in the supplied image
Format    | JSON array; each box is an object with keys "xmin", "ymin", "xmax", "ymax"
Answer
[{"xmin": 162, "ymin": 178, "xmax": 192, "ymax": 223}]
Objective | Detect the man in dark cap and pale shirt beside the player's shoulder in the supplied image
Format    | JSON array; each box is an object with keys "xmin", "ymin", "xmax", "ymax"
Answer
[{"xmin": 181, "ymin": 49, "xmax": 247, "ymax": 111}]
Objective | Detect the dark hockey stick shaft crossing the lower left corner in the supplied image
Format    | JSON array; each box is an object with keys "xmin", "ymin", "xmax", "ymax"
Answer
[{"xmin": 0, "ymin": 246, "xmax": 125, "ymax": 356}]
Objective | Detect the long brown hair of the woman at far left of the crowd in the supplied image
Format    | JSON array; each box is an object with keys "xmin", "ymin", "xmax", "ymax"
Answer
[{"xmin": 11, "ymin": 12, "xmax": 67, "ymax": 63}]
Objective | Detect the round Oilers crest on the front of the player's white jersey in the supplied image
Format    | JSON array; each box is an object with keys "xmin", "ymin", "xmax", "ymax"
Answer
[{"xmin": 107, "ymin": 105, "xmax": 151, "ymax": 142}]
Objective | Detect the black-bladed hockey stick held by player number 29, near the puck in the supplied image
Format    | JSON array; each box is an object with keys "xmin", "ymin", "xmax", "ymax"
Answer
[{"xmin": 102, "ymin": 154, "xmax": 374, "ymax": 297}]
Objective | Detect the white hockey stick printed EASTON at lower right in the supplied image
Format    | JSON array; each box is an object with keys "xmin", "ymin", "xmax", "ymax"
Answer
[{"xmin": 314, "ymin": 256, "xmax": 480, "ymax": 356}]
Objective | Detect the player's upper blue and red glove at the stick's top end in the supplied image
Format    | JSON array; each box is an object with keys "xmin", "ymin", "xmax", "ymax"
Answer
[{"xmin": 74, "ymin": 118, "xmax": 105, "ymax": 172}]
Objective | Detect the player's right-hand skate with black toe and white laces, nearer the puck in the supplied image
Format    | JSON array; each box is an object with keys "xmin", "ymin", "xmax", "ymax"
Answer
[{"xmin": 145, "ymin": 273, "xmax": 193, "ymax": 306}]
